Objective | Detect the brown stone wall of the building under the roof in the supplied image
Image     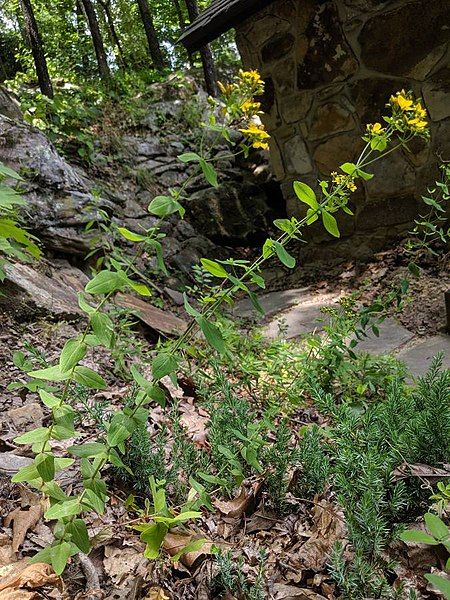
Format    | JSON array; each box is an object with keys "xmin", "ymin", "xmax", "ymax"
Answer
[{"xmin": 237, "ymin": 0, "xmax": 450, "ymax": 256}]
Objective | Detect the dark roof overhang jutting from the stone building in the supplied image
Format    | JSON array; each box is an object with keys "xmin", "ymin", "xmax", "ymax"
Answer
[{"xmin": 178, "ymin": 0, "xmax": 275, "ymax": 52}]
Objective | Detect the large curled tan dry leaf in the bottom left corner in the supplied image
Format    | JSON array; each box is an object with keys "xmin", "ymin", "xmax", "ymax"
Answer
[{"xmin": 0, "ymin": 561, "xmax": 62, "ymax": 600}]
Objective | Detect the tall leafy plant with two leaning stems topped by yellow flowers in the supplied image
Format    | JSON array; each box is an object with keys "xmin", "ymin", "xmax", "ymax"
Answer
[{"xmin": 13, "ymin": 79, "xmax": 427, "ymax": 573}]
